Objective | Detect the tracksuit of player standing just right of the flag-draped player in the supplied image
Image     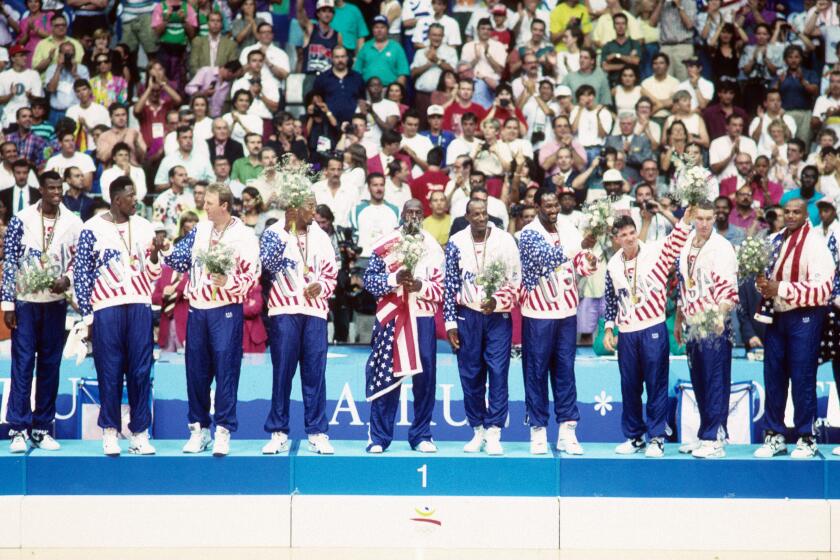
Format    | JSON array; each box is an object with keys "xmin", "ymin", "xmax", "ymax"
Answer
[{"xmin": 443, "ymin": 224, "xmax": 521, "ymax": 428}]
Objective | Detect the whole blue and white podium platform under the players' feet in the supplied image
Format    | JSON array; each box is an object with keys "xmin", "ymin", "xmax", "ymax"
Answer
[{"xmin": 0, "ymin": 439, "xmax": 840, "ymax": 551}]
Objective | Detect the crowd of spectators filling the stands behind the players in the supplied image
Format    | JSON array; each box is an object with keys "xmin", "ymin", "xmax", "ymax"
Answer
[{"xmin": 0, "ymin": 0, "xmax": 840, "ymax": 351}]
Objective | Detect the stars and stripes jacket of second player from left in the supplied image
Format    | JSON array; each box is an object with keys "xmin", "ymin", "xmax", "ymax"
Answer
[{"xmin": 73, "ymin": 215, "xmax": 160, "ymax": 325}]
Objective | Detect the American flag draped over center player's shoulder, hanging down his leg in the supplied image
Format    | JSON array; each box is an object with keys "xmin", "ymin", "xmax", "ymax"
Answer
[{"xmin": 365, "ymin": 230, "xmax": 422, "ymax": 401}]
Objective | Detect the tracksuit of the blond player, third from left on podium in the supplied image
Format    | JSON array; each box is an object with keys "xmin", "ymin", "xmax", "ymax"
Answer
[{"xmin": 164, "ymin": 218, "xmax": 260, "ymax": 432}]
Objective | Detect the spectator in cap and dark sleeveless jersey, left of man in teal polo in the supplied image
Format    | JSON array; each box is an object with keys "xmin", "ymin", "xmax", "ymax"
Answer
[{"xmin": 296, "ymin": 0, "xmax": 342, "ymax": 80}]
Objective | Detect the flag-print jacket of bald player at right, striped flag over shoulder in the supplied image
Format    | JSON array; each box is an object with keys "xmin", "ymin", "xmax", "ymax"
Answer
[{"xmin": 770, "ymin": 222, "xmax": 834, "ymax": 312}]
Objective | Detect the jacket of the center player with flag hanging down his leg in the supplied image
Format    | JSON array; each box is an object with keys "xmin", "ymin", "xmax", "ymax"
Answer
[{"xmin": 364, "ymin": 226, "xmax": 444, "ymax": 317}]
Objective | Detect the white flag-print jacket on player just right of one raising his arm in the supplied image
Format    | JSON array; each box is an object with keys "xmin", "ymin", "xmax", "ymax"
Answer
[{"xmin": 676, "ymin": 231, "xmax": 738, "ymax": 317}]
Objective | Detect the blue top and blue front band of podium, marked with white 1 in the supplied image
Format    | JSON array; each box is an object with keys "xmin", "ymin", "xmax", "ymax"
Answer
[{"xmin": 0, "ymin": 439, "xmax": 840, "ymax": 499}]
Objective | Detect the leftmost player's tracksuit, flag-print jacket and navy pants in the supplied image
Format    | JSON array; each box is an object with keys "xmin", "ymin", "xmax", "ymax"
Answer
[{"xmin": 0, "ymin": 202, "xmax": 82, "ymax": 432}]
